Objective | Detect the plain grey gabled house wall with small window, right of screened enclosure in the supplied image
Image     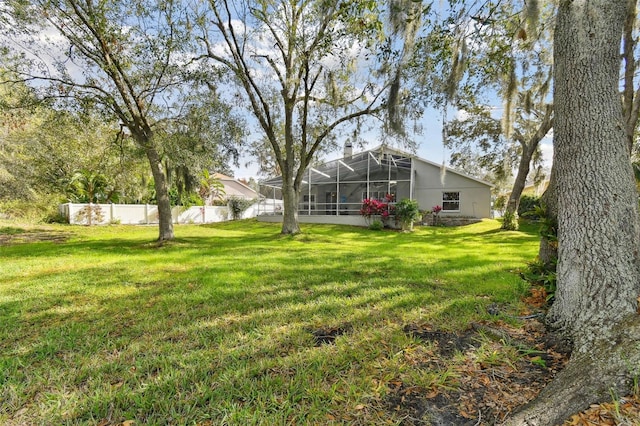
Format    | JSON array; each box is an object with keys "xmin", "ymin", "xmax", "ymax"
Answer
[{"xmin": 413, "ymin": 160, "xmax": 491, "ymax": 218}]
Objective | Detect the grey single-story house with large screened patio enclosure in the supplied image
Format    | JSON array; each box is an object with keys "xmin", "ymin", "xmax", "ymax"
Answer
[{"xmin": 261, "ymin": 144, "xmax": 492, "ymax": 224}]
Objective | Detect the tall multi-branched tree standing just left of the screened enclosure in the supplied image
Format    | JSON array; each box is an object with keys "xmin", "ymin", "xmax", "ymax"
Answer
[{"xmin": 191, "ymin": 0, "xmax": 415, "ymax": 234}]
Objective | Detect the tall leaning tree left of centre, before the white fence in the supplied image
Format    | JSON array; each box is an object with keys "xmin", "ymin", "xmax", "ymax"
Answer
[{"xmin": 4, "ymin": 0, "xmax": 192, "ymax": 241}]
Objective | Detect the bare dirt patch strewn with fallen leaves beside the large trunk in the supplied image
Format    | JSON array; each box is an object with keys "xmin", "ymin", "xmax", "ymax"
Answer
[{"xmin": 386, "ymin": 320, "xmax": 568, "ymax": 425}]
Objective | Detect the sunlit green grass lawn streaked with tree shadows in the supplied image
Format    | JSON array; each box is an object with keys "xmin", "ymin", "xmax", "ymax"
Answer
[{"xmin": 0, "ymin": 221, "xmax": 538, "ymax": 425}]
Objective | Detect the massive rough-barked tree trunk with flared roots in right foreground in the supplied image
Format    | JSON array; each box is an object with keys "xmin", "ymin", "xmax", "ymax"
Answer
[{"xmin": 507, "ymin": 0, "xmax": 640, "ymax": 426}]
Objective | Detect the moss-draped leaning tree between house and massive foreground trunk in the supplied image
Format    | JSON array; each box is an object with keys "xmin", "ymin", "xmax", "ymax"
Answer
[{"xmin": 444, "ymin": 1, "xmax": 554, "ymax": 229}]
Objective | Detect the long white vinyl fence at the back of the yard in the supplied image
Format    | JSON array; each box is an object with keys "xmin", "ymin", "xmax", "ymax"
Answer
[{"xmin": 58, "ymin": 199, "xmax": 282, "ymax": 225}]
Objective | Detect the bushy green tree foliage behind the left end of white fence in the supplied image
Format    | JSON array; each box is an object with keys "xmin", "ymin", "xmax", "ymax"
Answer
[{"xmin": 6, "ymin": 111, "xmax": 144, "ymax": 202}]
